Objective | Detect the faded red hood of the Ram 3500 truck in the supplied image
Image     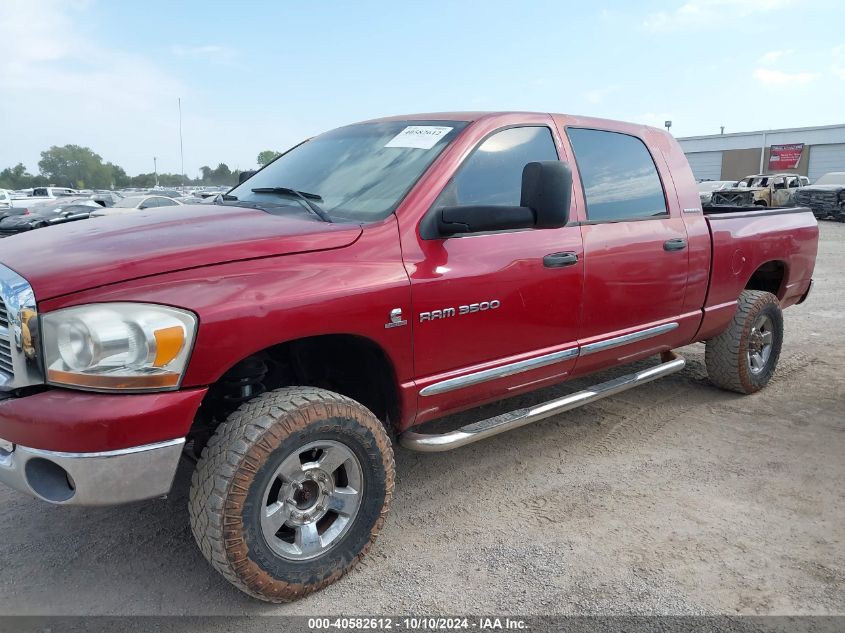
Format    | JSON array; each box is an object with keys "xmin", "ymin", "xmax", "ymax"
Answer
[{"xmin": 0, "ymin": 205, "xmax": 362, "ymax": 301}]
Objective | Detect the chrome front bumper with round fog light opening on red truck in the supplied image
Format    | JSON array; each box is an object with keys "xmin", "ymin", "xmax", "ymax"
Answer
[{"xmin": 0, "ymin": 438, "xmax": 185, "ymax": 506}]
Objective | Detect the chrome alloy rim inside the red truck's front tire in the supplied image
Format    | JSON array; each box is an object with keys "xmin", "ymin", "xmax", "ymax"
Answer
[{"xmin": 261, "ymin": 440, "xmax": 363, "ymax": 560}]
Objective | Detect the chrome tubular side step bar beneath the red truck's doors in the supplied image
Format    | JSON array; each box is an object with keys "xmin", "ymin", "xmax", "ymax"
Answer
[{"xmin": 399, "ymin": 352, "xmax": 686, "ymax": 453}]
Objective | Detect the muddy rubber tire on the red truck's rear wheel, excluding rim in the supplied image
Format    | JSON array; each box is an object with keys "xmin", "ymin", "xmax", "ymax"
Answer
[{"xmin": 704, "ymin": 290, "xmax": 783, "ymax": 394}]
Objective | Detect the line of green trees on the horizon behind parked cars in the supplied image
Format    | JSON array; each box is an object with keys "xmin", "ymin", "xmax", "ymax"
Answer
[{"xmin": 0, "ymin": 145, "xmax": 279, "ymax": 189}]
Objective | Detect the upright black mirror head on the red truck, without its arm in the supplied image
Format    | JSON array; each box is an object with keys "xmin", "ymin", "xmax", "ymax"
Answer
[{"xmin": 519, "ymin": 160, "xmax": 572, "ymax": 229}]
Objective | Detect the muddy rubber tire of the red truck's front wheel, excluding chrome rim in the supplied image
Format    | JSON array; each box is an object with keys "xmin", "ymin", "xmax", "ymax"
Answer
[{"xmin": 189, "ymin": 387, "xmax": 394, "ymax": 602}]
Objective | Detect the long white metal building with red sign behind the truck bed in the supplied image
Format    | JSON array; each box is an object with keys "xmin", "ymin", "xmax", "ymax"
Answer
[{"xmin": 678, "ymin": 123, "xmax": 845, "ymax": 181}]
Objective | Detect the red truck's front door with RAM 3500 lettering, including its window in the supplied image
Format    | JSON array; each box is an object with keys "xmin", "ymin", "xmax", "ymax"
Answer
[{"xmin": 406, "ymin": 118, "xmax": 583, "ymax": 422}]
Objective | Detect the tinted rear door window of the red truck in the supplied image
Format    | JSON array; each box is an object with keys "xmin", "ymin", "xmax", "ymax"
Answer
[{"xmin": 567, "ymin": 128, "xmax": 669, "ymax": 222}]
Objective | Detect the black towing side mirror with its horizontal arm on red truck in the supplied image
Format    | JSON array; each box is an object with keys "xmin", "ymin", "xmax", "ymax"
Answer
[{"xmin": 436, "ymin": 160, "xmax": 572, "ymax": 237}]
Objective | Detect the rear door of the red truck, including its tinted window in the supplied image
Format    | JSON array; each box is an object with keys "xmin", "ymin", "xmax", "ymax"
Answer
[{"xmin": 567, "ymin": 127, "xmax": 698, "ymax": 373}]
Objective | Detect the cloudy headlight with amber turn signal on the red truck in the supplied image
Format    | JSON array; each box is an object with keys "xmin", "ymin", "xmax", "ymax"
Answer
[{"xmin": 41, "ymin": 303, "xmax": 197, "ymax": 391}]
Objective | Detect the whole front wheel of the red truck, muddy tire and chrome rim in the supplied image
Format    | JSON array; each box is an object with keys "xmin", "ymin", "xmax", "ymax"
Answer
[{"xmin": 190, "ymin": 387, "xmax": 394, "ymax": 602}]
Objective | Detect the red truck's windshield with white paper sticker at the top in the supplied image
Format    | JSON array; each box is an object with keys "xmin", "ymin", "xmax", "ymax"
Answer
[{"xmin": 225, "ymin": 120, "xmax": 467, "ymax": 222}]
